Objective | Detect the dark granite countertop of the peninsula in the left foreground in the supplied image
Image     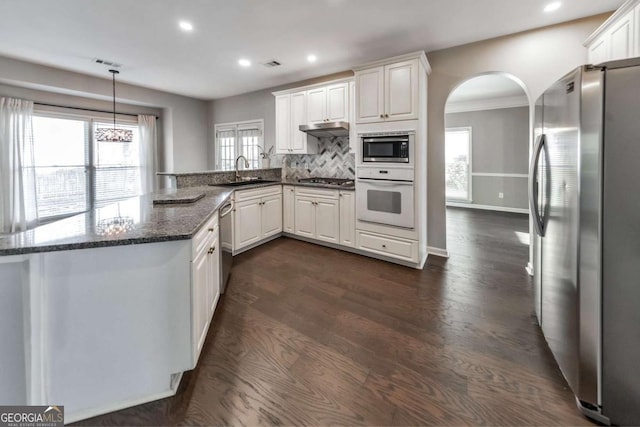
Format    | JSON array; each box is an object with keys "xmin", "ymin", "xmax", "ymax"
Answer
[{"xmin": 0, "ymin": 186, "xmax": 233, "ymax": 256}]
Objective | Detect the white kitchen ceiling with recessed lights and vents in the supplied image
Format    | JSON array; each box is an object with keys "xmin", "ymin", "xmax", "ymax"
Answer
[{"xmin": 0, "ymin": 0, "xmax": 624, "ymax": 99}]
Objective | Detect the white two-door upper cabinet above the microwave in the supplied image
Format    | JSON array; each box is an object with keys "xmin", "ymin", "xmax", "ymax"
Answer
[{"xmin": 355, "ymin": 53, "xmax": 429, "ymax": 124}]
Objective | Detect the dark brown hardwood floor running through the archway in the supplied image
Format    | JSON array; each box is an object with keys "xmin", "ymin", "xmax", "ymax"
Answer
[{"xmin": 78, "ymin": 209, "xmax": 591, "ymax": 426}]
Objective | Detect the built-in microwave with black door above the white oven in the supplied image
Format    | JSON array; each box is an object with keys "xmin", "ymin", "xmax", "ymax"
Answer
[{"xmin": 360, "ymin": 132, "xmax": 414, "ymax": 163}]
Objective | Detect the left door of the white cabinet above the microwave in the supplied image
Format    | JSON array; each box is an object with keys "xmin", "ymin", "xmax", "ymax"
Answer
[{"xmin": 356, "ymin": 67, "xmax": 384, "ymax": 123}]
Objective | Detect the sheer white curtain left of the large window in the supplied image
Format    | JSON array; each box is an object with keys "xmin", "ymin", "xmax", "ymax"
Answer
[{"xmin": 0, "ymin": 98, "xmax": 38, "ymax": 234}]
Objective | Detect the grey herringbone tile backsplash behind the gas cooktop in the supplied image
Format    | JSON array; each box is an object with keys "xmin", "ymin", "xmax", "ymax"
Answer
[{"xmin": 282, "ymin": 137, "xmax": 356, "ymax": 180}]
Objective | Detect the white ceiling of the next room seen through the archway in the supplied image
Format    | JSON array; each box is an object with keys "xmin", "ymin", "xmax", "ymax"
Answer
[{"xmin": 447, "ymin": 74, "xmax": 526, "ymax": 103}]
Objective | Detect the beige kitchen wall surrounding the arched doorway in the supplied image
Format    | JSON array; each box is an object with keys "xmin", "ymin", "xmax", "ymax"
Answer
[{"xmin": 427, "ymin": 14, "xmax": 609, "ymax": 249}]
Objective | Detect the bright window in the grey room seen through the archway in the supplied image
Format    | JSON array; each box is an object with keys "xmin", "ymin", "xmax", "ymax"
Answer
[{"xmin": 445, "ymin": 127, "xmax": 471, "ymax": 202}]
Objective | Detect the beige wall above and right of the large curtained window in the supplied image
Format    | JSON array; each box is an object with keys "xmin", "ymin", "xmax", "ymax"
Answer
[{"xmin": 0, "ymin": 57, "xmax": 209, "ymax": 179}]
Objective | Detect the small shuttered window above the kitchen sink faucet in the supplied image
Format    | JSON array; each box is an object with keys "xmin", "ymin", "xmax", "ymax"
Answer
[{"xmin": 215, "ymin": 120, "xmax": 264, "ymax": 170}]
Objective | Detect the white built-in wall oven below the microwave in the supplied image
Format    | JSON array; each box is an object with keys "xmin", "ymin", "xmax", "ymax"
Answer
[{"xmin": 356, "ymin": 167, "xmax": 415, "ymax": 229}]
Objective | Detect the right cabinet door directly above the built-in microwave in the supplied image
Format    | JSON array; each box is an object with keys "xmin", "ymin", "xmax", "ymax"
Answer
[{"xmin": 384, "ymin": 60, "xmax": 418, "ymax": 120}]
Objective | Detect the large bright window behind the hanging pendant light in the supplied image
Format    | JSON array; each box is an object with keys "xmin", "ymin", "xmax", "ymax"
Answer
[{"xmin": 33, "ymin": 113, "xmax": 141, "ymax": 221}]
